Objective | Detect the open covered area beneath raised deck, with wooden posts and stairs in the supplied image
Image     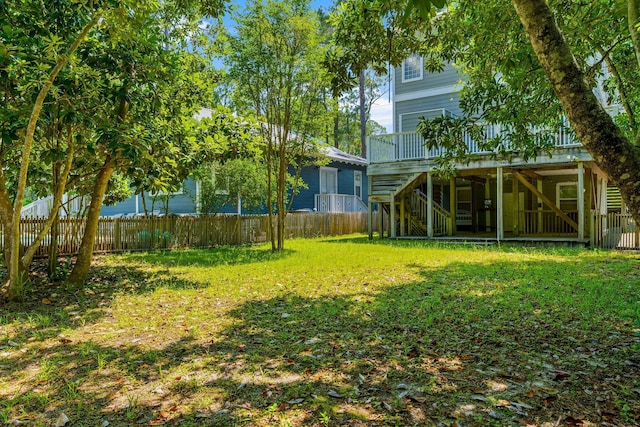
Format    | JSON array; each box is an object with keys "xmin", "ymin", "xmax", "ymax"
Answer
[{"xmin": 369, "ymin": 159, "xmax": 607, "ymax": 245}]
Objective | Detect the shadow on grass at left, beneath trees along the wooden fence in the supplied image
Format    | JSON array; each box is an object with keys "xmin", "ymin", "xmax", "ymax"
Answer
[{"xmin": 0, "ymin": 246, "xmax": 294, "ymax": 341}]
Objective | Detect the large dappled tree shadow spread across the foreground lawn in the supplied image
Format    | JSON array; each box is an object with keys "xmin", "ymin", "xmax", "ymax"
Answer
[{"xmin": 0, "ymin": 251, "xmax": 640, "ymax": 426}]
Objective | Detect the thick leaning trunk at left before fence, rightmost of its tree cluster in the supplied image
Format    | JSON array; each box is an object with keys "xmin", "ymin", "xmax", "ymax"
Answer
[{"xmin": 67, "ymin": 158, "xmax": 115, "ymax": 287}]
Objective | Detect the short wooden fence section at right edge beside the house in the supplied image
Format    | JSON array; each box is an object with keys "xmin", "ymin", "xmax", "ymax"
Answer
[{"xmin": 591, "ymin": 211, "xmax": 640, "ymax": 249}]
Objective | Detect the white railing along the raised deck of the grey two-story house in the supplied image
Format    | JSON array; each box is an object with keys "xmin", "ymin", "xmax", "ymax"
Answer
[{"xmin": 367, "ymin": 125, "xmax": 581, "ymax": 163}]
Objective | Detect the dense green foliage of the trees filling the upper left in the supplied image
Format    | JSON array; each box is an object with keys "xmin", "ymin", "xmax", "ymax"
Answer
[{"xmin": 0, "ymin": 0, "xmax": 230, "ymax": 294}]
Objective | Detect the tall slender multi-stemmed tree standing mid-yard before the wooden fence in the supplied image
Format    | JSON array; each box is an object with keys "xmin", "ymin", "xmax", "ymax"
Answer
[{"xmin": 224, "ymin": 0, "xmax": 330, "ymax": 250}]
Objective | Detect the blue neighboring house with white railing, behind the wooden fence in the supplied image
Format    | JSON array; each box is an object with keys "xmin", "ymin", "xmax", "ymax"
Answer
[{"xmin": 100, "ymin": 146, "xmax": 368, "ymax": 216}]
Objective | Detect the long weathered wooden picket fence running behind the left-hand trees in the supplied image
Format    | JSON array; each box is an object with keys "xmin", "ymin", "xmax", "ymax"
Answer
[{"xmin": 0, "ymin": 213, "xmax": 377, "ymax": 256}]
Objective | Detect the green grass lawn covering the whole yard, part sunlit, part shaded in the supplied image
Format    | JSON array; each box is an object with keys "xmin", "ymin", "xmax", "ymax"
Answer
[{"xmin": 0, "ymin": 236, "xmax": 640, "ymax": 426}]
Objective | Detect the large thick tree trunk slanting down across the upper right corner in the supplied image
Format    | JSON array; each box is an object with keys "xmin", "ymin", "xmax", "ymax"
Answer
[{"xmin": 512, "ymin": 0, "xmax": 640, "ymax": 222}]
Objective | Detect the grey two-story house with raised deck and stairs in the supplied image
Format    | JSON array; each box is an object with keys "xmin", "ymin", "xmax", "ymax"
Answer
[{"xmin": 367, "ymin": 56, "xmax": 608, "ymax": 244}]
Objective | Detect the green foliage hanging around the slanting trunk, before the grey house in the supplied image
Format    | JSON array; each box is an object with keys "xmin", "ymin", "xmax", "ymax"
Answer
[{"xmin": 400, "ymin": 0, "xmax": 640, "ymax": 166}]
